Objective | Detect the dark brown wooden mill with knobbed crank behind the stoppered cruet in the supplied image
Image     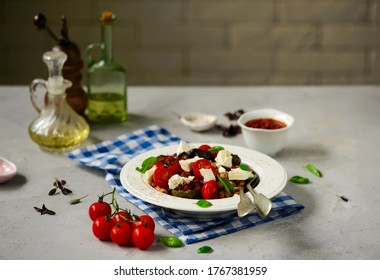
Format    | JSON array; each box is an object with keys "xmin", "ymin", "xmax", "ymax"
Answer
[{"xmin": 33, "ymin": 13, "xmax": 87, "ymax": 116}]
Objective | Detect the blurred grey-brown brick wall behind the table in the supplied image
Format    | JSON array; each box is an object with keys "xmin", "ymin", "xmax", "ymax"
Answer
[{"xmin": 0, "ymin": 0, "xmax": 380, "ymax": 85}]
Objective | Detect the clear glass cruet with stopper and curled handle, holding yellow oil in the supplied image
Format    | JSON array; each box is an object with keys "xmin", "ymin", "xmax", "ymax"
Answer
[{"xmin": 29, "ymin": 50, "xmax": 90, "ymax": 152}]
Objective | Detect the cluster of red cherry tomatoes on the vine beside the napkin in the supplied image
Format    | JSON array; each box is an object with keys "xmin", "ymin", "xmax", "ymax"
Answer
[{"xmin": 88, "ymin": 189, "xmax": 155, "ymax": 250}]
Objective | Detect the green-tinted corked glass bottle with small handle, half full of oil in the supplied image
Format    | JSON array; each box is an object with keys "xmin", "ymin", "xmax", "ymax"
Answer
[{"xmin": 87, "ymin": 12, "xmax": 127, "ymax": 123}]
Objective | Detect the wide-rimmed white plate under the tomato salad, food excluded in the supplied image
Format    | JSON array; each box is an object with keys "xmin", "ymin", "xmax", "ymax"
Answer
[{"xmin": 120, "ymin": 143, "xmax": 287, "ymax": 218}]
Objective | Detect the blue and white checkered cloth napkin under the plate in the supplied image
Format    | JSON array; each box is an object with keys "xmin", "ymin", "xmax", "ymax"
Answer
[{"xmin": 66, "ymin": 125, "xmax": 304, "ymax": 244}]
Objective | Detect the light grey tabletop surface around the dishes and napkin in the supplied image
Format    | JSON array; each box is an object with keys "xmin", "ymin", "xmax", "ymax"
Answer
[{"xmin": 0, "ymin": 86, "xmax": 380, "ymax": 260}]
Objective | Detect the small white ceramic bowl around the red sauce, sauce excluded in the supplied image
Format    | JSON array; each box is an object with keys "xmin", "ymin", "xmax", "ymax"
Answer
[{"xmin": 238, "ymin": 109, "xmax": 294, "ymax": 156}]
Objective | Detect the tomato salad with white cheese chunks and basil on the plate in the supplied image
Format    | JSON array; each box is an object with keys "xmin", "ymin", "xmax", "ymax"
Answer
[{"xmin": 136, "ymin": 141, "xmax": 255, "ymax": 199}]
